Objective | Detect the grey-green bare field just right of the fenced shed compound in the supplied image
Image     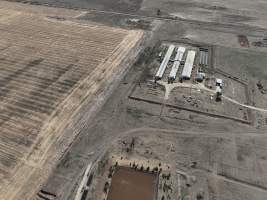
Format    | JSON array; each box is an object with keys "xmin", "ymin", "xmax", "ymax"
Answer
[{"xmin": 215, "ymin": 47, "xmax": 267, "ymax": 108}]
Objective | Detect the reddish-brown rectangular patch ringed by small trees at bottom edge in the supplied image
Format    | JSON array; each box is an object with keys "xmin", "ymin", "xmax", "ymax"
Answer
[{"xmin": 108, "ymin": 167, "xmax": 156, "ymax": 200}]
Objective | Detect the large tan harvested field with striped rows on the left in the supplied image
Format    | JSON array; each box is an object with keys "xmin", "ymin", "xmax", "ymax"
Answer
[{"xmin": 0, "ymin": 2, "xmax": 142, "ymax": 200}]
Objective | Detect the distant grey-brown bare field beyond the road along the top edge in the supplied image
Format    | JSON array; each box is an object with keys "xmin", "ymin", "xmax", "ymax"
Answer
[{"xmin": 9, "ymin": 0, "xmax": 267, "ymax": 28}]
